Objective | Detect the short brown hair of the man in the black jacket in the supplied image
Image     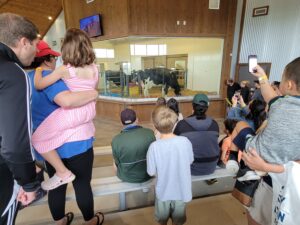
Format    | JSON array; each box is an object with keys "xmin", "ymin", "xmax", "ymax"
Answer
[{"xmin": 0, "ymin": 13, "xmax": 39, "ymax": 47}]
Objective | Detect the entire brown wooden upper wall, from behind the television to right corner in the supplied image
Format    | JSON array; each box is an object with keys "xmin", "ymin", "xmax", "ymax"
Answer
[{"xmin": 63, "ymin": 0, "xmax": 237, "ymax": 37}]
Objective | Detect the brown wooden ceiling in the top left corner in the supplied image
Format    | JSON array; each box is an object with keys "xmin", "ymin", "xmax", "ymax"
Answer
[{"xmin": 0, "ymin": 0, "xmax": 62, "ymax": 37}]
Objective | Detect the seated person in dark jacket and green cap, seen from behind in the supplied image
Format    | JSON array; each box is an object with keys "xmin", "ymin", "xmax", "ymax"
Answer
[{"xmin": 174, "ymin": 94, "xmax": 220, "ymax": 175}]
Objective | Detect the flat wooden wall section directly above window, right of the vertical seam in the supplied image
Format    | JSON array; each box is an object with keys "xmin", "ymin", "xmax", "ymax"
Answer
[{"xmin": 128, "ymin": 0, "xmax": 236, "ymax": 36}]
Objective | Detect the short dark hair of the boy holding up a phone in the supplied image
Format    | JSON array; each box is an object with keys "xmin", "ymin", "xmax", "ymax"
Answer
[{"xmin": 284, "ymin": 57, "xmax": 300, "ymax": 91}]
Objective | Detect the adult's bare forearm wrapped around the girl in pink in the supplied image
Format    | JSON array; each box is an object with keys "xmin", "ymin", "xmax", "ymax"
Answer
[{"xmin": 54, "ymin": 90, "xmax": 98, "ymax": 108}]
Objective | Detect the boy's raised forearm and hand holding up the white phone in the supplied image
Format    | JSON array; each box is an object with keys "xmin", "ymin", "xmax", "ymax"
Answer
[{"xmin": 252, "ymin": 65, "xmax": 278, "ymax": 103}]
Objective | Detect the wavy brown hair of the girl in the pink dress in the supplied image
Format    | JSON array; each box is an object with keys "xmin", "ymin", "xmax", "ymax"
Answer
[{"xmin": 61, "ymin": 28, "xmax": 96, "ymax": 67}]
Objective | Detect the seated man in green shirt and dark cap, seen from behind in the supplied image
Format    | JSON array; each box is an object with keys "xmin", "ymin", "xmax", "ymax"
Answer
[{"xmin": 111, "ymin": 109, "xmax": 155, "ymax": 183}]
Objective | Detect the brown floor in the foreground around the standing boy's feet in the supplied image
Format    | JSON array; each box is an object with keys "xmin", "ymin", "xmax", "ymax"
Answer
[{"xmin": 17, "ymin": 194, "xmax": 247, "ymax": 225}]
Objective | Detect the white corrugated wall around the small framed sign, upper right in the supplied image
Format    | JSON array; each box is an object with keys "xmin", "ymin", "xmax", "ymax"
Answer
[{"xmin": 240, "ymin": 0, "xmax": 300, "ymax": 81}]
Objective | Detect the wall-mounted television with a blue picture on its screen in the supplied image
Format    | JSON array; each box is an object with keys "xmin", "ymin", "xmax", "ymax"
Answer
[{"xmin": 79, "ymin": 14, "xmax": 103, "ymax": 37}]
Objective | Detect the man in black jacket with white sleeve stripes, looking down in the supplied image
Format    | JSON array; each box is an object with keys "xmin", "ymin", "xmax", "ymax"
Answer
[{"xmin": 0, "ymin": 13, "xmax": 40, "ymax": 225}]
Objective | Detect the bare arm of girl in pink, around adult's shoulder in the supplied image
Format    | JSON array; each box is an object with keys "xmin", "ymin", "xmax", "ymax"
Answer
[{"xmin": 34, "ymin": 67, "xmax": 65, "ymax": 90}]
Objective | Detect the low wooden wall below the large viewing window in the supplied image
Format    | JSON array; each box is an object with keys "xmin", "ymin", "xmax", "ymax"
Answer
[{"xmin": 96, "ymin": 99, "xmax": 225, "ymax": 122}]
